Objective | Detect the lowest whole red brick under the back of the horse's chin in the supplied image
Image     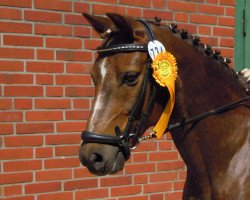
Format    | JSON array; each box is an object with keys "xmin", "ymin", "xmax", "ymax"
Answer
[{"xmin": 111, "ymin": 185, "xmax": 142, "ymax": 197}]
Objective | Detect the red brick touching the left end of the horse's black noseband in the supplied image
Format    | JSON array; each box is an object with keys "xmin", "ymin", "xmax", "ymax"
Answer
[{"xmin": 45, "ymin": 133, "xmax": 81, "ymax": 145}]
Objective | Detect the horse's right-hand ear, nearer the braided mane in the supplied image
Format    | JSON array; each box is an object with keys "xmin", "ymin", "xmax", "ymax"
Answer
[{"xmin": 106, "ymin": 13, "xmax": 134, "ymax": 38}]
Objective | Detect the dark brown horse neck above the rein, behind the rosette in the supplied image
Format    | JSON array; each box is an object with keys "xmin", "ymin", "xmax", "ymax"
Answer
[{"xmin": 154, "ymin": 31, "xmax": 245, "ymax": 121}]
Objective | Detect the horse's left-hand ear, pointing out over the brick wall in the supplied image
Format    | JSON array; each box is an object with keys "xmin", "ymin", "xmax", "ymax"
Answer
[{"xmin": 82, "ymin": 13, "xmax": 112, "ymax": 33}]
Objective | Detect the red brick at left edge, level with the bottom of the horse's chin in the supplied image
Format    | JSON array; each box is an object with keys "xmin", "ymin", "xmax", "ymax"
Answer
[{"xmin": 0, "ymin": 172, "xmax": 33, "ymax": 185}]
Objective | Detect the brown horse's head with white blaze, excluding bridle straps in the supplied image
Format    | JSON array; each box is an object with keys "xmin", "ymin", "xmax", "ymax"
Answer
[{"xmin": 79, "ymin": 14, "xmax": 167, "ymax": 175}]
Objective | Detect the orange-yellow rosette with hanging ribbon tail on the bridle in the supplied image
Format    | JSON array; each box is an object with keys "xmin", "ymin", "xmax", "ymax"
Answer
[{"xmin": 152, "ymin": 51, "xmax": 177, "ymax": 139}]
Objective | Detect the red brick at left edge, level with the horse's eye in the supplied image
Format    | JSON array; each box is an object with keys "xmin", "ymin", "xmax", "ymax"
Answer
[{"xmin": 0, "ymin": 74, "xmax": 34, "ymax": 84}]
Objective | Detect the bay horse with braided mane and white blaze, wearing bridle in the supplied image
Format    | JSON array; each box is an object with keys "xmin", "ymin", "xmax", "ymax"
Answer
[{"xmin": 79, "ymin": 13, "xmax": 250, "ymax": 200}]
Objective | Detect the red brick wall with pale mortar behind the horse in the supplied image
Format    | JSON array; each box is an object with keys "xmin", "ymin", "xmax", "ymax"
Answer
[{"xmin": 0, "ymin": 0, "xmax": 235, "ymax": 200}]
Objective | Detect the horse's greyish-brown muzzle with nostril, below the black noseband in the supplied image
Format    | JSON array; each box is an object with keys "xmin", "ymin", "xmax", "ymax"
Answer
[{"xmin": 79, "ymin": 145, "xmax": 125, "ymax": 176}]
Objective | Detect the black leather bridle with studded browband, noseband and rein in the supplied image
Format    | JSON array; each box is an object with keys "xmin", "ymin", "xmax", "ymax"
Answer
[{"xmin": 81, "ymin": 20, "xmax": 250, "ymax": 160}]
